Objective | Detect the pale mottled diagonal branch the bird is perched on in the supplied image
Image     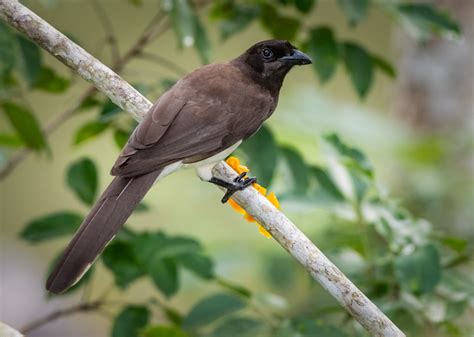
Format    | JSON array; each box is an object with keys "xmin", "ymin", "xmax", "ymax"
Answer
[{"xmin": 0, "ymin": 0, "xmax": 405, "ymax": 337}]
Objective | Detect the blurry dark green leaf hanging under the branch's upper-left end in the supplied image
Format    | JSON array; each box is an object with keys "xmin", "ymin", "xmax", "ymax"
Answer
[{"xmin": 17, "ymin": 35, "xmax": 41, "ymax": 87}]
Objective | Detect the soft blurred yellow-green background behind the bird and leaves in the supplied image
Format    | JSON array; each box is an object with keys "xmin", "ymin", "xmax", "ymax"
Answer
[{"xmin": 0, "ymin": 0, "xmax": 474, "ymax": 336}]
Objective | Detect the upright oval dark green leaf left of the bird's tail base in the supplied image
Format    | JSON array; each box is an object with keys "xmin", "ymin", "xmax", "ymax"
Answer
[{"xmin": 66, "ymin": 158, "xmax": 98, "ymax": 205}]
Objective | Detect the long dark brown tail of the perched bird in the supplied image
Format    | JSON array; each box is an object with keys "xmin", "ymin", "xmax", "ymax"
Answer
[{"xmin": 46, "ymin": 170, "xmax": 161, "ymax": 294}]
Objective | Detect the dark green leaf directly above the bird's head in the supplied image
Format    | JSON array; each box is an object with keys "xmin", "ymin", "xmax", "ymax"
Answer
[{"xmin": 260, "ymin": 3, "xmax": 301, "ymax": 41}]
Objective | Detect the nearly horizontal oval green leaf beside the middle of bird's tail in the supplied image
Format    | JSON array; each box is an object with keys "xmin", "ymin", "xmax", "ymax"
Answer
[{"xmin": 20, "ymin": 212, "xmax": 82, "ymax": 242}]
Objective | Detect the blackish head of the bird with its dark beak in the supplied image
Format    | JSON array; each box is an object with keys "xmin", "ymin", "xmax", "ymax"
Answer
[{"xmin": 233, "ymin": 40, "xmax": 312, "ymax": 90}]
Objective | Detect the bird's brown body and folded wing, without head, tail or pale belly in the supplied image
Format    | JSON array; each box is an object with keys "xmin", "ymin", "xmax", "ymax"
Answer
[{"xmin": 112, "ymin": 64, "xmax": 276, "ymax": 176}]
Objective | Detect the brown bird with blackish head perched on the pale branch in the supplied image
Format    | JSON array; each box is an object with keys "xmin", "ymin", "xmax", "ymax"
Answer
[{"xmin": 46, "ymin": 40, "xmax": 312, "ymax": 294}]
